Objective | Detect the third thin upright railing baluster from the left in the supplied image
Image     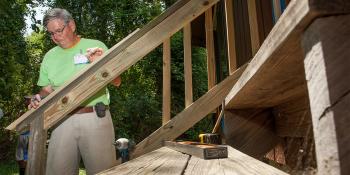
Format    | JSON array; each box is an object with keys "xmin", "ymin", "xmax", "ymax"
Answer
[{"xmin": 205, "ymin": 8, "xmax": 216, "ymax": 90}]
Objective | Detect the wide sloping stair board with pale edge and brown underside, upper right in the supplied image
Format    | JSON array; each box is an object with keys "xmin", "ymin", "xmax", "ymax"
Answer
[{"xmin": 225, "ymin": 0, "xmax": 350, "ymax": 109}]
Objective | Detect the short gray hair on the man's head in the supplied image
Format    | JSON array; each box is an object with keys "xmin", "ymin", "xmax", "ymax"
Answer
[{"xmin": 43, "ymin": 8, "xmax": 73, "ymax": 28}]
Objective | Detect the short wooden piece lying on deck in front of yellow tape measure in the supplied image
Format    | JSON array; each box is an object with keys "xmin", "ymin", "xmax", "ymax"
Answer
[{"xmin": 164, "ymin": 141, "xmax": 228, "ymax": 160}]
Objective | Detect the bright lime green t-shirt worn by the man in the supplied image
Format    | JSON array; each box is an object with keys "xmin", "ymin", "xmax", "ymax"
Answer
[{"xmin": 37, "ymin": 38, "xmax": 110, "ymax": 106}]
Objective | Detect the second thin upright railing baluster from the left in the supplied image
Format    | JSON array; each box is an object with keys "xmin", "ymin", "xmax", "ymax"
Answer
[{"xmin": 183, "ymin": 23, "xmax": 193, "ymax": 107}]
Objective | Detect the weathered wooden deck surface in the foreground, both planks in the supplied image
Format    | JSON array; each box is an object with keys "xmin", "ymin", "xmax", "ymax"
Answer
[{"xmin": 99, "ymin": 146, "xmax": 286, "ymax": 175}]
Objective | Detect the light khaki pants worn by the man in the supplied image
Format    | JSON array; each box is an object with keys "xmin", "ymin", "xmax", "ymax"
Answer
[{"xmin": 46, "ymin": 108, "xmax": 116, "ymax": 175}]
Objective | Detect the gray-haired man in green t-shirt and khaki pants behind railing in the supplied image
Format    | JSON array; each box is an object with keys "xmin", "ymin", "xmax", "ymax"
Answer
[{"xmin": 29, "ymin": 8, "xmax": 121, "ymax": 175}]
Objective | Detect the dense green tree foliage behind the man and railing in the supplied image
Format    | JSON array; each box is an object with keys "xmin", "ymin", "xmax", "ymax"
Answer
[{"xmin": 0, "ymin": 0, "xmax": 213, "ymax": 159}]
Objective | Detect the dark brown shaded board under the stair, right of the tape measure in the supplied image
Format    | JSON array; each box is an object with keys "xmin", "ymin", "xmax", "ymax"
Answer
[{"xmin": 224, "ymin": 109, "xmax": 280, "ymax": 159}]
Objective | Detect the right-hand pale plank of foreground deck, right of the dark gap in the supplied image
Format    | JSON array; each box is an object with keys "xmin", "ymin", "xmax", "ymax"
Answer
[{"xmin": 184, "ymin": 146, "xmax": 286, "ymax": 175}]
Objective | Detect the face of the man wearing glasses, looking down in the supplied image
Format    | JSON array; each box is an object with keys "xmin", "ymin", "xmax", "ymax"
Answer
[{"xmin": 47, "ymin": 19, "xmax": 76, "ymax": 49}]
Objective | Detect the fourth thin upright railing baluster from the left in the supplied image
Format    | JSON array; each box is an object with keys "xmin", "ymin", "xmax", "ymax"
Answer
[{"xmin": 224, "ymin": 0, "xmax": 237, "ymax": 75}]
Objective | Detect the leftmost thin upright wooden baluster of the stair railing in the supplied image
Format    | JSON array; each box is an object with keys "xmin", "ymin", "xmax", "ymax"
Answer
[{"xmin": 162, "ymin": 38, "xmax": 171, "ymax": 125}]
